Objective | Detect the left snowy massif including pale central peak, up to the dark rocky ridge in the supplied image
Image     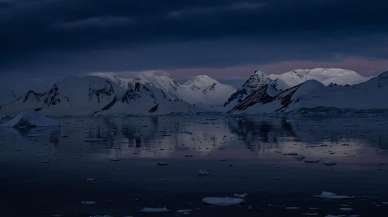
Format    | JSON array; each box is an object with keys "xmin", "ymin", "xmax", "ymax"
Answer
[{"xmin": 0, "ymin": 72, "xmax": 235, "ymax": 116}]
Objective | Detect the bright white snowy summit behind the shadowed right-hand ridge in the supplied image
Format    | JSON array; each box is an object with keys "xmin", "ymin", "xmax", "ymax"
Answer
[{"xmin": 268, "ymin": 68, "xmax": 369, "ymax": 87}]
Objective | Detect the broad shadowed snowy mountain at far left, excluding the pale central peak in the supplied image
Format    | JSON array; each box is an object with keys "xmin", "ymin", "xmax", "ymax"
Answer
[{"xmin": 0, "ymin": 76, "xmax": 192, "ymax": 116}]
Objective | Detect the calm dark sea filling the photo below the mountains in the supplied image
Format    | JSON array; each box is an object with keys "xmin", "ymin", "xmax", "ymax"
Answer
[{"xmin": 0, "ymin": 116, "xmax": 388, "ymax": 217}]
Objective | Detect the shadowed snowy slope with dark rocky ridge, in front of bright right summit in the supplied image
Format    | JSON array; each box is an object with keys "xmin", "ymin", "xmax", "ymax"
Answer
[{"xmin": 229, "ymin": 72, "xmax": 388, "ymax": 114}]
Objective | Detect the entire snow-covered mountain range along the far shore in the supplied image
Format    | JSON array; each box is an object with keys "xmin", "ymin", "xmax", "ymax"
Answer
[{"xmin": 0, "ymin": 68, "xmax": 388, "ymax": 116}]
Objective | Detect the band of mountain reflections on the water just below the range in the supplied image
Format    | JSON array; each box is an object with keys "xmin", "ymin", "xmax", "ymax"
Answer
[{"xmin": 0, "ymin": 116, "xmax": 388, "ymax": 161}]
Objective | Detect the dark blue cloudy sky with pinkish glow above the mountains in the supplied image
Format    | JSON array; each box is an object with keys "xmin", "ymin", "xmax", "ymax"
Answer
[{"xmin": 0, "ymin": 0, "xmax": 388, "ymax": 80}]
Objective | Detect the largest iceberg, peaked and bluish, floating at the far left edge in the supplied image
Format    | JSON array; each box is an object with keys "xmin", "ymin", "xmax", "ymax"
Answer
[{"xmin": 0, "ymin": 112, "xmax": 60, "ymax": 129}]
